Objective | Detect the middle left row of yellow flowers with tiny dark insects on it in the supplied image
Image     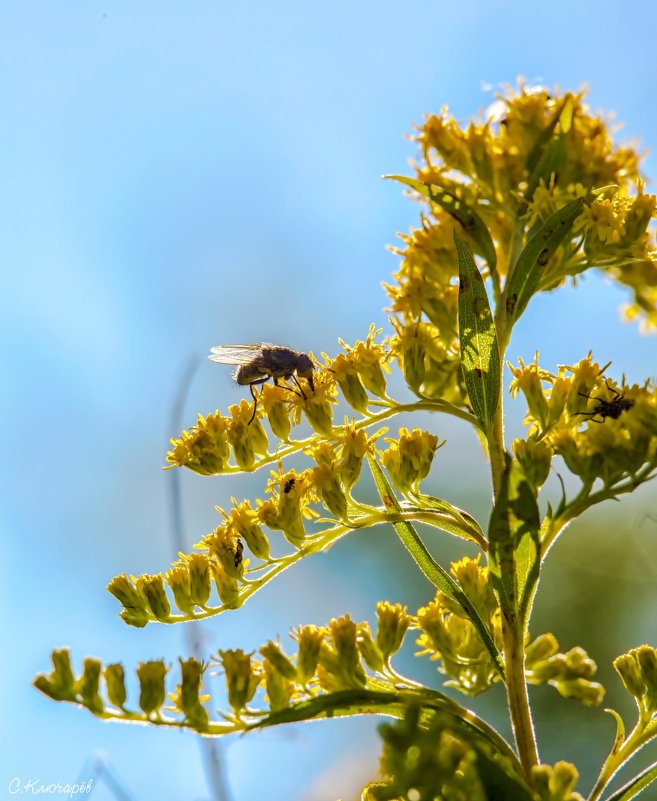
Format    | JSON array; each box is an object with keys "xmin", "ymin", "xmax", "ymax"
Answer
[{"xmin": 108, "ymin": 428, "xmax": 400, "ymax": 626}]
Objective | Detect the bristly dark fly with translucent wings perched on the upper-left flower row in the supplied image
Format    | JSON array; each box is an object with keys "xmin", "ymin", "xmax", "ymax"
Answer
[{"xmin": 208, "ymin": 342, "xmax": 315, "ymax": 425}]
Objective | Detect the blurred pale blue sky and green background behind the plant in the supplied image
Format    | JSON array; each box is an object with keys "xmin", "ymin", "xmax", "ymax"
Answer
[{"xmin": 0, "ymin": 0, "xmax": 657, "ymax": 801}]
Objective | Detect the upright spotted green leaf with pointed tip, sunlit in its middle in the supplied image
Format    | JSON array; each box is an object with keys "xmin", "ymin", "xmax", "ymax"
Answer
[{"xmin": 454, "ymin": 234, "xmax": 500, "ymax": 431}]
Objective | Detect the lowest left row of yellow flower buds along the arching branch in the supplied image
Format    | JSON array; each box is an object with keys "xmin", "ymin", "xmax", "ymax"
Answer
[{"xmin": 35, "ymin": 602, "xmax": 411, "ymax": 731}]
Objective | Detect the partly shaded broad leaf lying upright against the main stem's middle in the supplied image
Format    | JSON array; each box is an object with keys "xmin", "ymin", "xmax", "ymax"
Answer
[{"xmin": 488, "ymin": 453, "xmax": 540, "ymax": 632}]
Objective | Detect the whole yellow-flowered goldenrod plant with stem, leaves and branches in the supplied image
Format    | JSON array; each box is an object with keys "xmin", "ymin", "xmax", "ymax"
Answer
[{"xmin": 35, "ymin": 83, "xmax": 657, "ymax": 801}]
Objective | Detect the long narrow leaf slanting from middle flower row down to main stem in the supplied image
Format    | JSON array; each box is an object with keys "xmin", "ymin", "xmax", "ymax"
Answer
[{"xmin": 367, "ymin": 455, "xmax": 504, "ymax": 679}]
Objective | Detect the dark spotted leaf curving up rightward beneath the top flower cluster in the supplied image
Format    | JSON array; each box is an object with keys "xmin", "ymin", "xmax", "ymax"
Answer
[{"xmin": 504, "ymin": 189, "xmax": 603, "ymax": 325}]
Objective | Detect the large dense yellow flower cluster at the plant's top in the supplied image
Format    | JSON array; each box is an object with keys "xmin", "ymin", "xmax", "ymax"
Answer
[{"xmin": 386, "ymin": 83, "xmax": 657, "ymax": 348}]
